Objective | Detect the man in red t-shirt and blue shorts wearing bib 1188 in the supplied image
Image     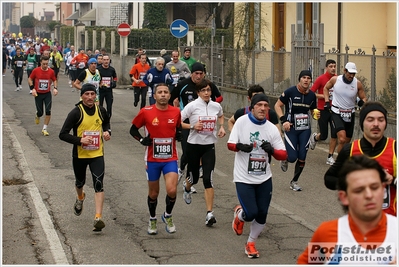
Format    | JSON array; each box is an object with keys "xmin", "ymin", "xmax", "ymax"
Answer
[{"xmin": 130, "ymin": 83, "xmax": 181, "ymax": 235}]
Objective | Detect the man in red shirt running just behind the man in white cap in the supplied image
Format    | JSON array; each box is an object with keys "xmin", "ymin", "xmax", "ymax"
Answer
[{"xmin": 310, "ymin": 59, "xmax": 337, "ymax": 165}]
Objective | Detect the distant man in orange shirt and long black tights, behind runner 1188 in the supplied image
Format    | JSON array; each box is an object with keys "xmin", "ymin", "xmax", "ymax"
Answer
[{"xmin": 129, "ymin": 54, "xmax": 150, "ymax": 108}]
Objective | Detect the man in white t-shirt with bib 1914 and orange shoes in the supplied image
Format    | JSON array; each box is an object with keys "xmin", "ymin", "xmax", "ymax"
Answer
[{"xmin": 227, "ymin": 94, "xmax": 287, "ymax": 258}]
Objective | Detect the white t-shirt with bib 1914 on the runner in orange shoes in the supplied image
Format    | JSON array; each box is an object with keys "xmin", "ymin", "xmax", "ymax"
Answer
[{"xmin": 227, "ymin": 114, "xmax": 285, "ymax": 184}]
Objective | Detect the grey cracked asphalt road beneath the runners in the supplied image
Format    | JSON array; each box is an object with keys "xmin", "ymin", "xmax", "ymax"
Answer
[{"xmin": 2, "ymin": 70, "xmax": 343, "ymax": 265}]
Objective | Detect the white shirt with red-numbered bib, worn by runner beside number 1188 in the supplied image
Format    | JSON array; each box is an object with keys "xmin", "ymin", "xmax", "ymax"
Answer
[{"xmin": 181, "ymin": 97, "xmax": 223, "ymax": 145}]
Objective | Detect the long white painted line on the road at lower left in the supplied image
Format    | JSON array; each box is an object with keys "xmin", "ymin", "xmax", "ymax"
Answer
[{"xmin": 3, "ymin": 121, "xmax": 69, "ymax": 265}]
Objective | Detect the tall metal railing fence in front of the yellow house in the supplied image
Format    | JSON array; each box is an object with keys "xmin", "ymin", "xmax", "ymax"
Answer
[{"xmin": 192, "ymin": 25, "xmax": 397, "ymax": 112}]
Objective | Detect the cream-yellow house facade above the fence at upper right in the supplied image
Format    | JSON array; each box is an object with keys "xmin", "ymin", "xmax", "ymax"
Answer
[{"xmin": 234, "ymin": 2, "xmax": 398, "ymax": 53}]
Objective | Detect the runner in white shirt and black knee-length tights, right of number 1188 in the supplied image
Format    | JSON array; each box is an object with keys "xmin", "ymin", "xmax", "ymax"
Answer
[{"xmin": 181, "ymin": 79, "xmax": 226, "ymax": 226}]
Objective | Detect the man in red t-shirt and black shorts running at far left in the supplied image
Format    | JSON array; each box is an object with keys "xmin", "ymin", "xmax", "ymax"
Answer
[{"xmin": 28, "ymin": 56, "xmax": 58, "ymax": 136}]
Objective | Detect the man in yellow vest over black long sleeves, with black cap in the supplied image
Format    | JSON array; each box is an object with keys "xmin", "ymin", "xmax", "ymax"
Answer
[{"xmin": 59, "ymin": 83, "xmax": 111, "ymax": 232}]
